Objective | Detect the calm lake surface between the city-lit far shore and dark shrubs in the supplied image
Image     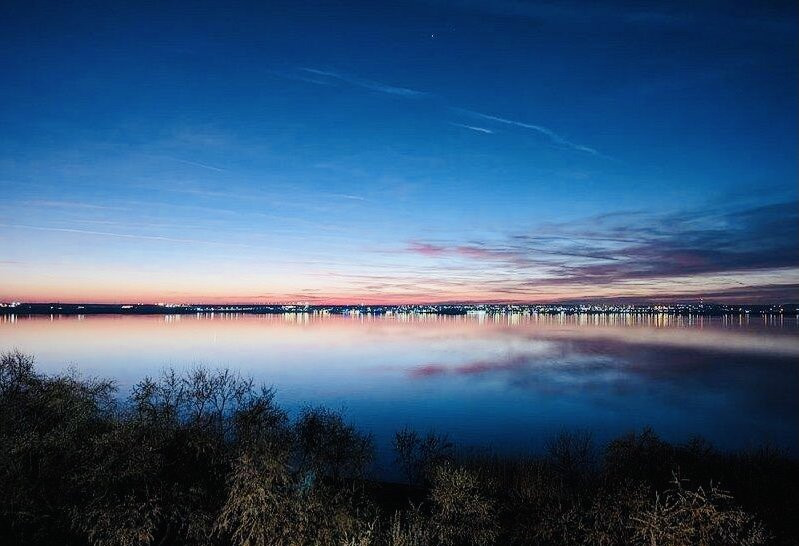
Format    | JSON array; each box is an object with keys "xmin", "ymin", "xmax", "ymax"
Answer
[{"xmin": 0, "ymin": 314, "xmax": 799, "ymax": 460}]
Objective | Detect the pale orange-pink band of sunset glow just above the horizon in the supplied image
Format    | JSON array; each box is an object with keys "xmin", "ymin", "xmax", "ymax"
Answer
[{"xmin": 0, "ymin": 269, "xmax": 799, "ymax": 305}]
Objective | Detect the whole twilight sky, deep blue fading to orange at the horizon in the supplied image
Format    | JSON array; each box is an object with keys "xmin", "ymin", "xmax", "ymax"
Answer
[{"xmin": 0, "ymin": 0, "xmax": 799, "ymax": 303}]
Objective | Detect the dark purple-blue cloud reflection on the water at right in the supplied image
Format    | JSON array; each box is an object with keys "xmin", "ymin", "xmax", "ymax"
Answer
[{"xmin": 407, "ymin": 339, "xmax": 799, "ymax": 418}]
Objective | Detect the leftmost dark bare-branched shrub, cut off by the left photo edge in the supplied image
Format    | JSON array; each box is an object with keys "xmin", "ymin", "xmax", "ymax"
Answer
[{"xmin": 0, "ymin": 352, "xmax": 115, "ymax": 543}]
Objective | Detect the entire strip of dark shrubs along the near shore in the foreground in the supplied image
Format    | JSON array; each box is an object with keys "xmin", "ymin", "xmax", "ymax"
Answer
[{"xmin": 0, "ymin": 353, "xmax": 799, "ymax": 546}]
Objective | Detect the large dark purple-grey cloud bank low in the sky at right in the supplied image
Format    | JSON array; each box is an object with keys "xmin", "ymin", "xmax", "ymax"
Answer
[{"xmin": 404, "ymin": 202, "xmax": 799, "ymax": 299}]
